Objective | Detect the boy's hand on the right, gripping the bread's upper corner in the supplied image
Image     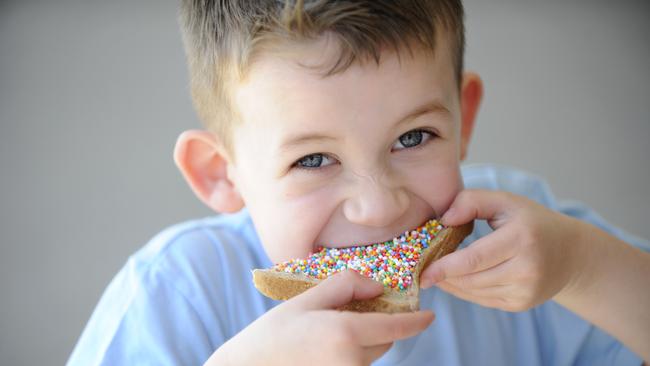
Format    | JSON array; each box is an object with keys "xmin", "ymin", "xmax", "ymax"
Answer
[{"xmin": 421, "ymin": 190, "xmax": 581, "ymax": 311}]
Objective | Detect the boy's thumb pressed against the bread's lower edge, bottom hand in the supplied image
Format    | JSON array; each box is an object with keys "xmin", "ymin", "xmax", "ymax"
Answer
[{"xmin": 296, "ymin": 270, "xmax": 384, "ymax": 310}]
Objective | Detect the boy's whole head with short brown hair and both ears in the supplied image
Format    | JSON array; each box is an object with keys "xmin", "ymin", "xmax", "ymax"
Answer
[{"xmin": 175, "ymin": 0, "xmax": 482, "ymax": 262}]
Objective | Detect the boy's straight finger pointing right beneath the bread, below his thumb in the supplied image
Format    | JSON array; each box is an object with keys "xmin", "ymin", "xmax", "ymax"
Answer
[{"xmin": 341, "ymin": 311, "xmax": 435, "ymax": 347}]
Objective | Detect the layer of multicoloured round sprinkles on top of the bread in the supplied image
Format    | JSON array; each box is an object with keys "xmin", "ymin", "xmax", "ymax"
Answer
[{"xmin": 273, "ymin": 220, "xmax": 442, "ymax": 290}]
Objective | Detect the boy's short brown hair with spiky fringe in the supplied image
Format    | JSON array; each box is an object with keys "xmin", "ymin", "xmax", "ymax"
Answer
[{"xmin": 180, "ymin": 0, "xmax": 465, "ymax": 149}]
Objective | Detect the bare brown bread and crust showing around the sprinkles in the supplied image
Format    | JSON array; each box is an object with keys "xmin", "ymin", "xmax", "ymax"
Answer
[{"xmin": 253, "ymin": 222, "xmax": 474, "ymax": 313}]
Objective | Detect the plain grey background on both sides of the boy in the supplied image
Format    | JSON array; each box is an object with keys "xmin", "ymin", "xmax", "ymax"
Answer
[{"xmin": 0, "ymin": 0, "xmax": 650, "ymax": 365}]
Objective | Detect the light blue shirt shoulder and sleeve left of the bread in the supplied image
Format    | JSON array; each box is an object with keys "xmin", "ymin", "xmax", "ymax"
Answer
[{"xmin": 69, "ymin": 210, "xmax": 274, "ymax": 365}]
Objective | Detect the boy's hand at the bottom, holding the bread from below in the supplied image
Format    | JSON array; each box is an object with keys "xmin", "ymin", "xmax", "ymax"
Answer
[{"xmin": 206, "ymin": 271, "xmax": 434, "ymax": 365}]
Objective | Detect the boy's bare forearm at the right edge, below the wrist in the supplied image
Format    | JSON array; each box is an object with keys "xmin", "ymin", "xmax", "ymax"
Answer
[{"xmin": 554, "ymin": 218, "xmax": 650, "ymax": 361}]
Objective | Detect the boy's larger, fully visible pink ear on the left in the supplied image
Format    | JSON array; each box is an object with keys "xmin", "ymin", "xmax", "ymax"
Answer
[{"xmin": 174, "ymin": 130, "xmax": 244, "ymax": 213}]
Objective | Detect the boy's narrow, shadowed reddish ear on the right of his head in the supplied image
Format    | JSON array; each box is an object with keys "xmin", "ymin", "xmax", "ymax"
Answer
[{"xmin": 460, "ymin": 72, "xmax": 483, "ymax": 160}]
